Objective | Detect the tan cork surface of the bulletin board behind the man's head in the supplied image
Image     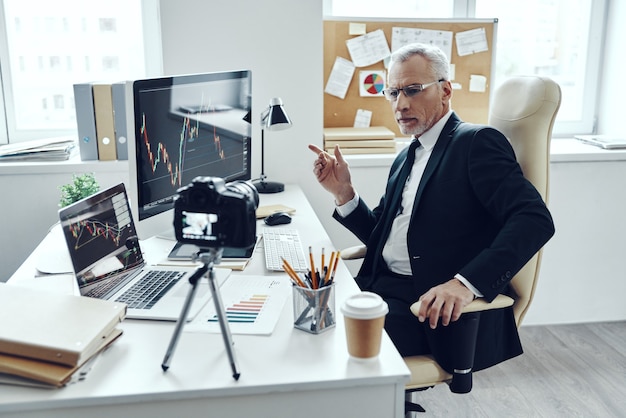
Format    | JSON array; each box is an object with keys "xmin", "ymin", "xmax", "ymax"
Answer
[{"xmin": 324, "ymin": 18, "xmax": 497, "ymax": 136}]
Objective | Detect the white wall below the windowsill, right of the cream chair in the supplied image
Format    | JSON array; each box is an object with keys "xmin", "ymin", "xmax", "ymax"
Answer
[{"xmin": 524, "ymin": 158, "xmax": 626, "ymax": 325}]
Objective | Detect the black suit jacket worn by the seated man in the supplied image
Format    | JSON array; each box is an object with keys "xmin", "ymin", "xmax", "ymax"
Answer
[{"xmin": 333, "ymin": 113, "xmax": 554, "ymax": 370}]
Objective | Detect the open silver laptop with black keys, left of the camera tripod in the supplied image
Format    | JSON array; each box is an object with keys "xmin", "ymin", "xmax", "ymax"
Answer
[{"xmin": 59, "ymin": 183, "xmax": 230, "ymax": 321}]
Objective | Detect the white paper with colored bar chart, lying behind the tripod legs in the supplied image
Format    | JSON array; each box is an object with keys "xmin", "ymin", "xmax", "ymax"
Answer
[{"xmin": 184, "ymin": 275, "xmax": 291, "ymax": 335}]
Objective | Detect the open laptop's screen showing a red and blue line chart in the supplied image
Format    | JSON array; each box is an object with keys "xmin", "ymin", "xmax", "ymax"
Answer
[{"xmin": 59, "ymin": 183, "xmax": 144, "ymax": 293}]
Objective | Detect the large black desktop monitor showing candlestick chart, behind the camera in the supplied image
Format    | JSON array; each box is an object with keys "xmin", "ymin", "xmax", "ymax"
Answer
[{"xmin": 126, "ymin": 70, "xmax": 252, "ymax": 240}]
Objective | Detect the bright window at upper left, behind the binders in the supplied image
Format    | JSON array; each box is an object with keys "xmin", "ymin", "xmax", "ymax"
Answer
[{"xmin": 0, "ymin": 0, "xmax": 161, "ymax": 144}]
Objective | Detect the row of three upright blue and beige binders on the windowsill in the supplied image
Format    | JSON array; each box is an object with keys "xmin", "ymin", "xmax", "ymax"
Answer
[{"xmin": 74, "ymin": 81, "xmax": 128, "ymax": 161}]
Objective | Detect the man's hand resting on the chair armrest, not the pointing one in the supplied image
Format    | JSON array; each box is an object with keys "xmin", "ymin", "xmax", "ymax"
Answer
[{"xmin": 418, "ymin": 279, "xmax": 474, "ymax": 329}]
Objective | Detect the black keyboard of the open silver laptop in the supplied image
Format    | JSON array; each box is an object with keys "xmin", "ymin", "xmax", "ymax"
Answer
[{"xmin": 116, "ymin": 270, "xmax": 184, "ymax": 309}]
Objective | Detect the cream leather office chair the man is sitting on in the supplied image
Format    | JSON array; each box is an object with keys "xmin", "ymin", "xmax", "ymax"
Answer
[{"xmin": 341, "ymin": 76, "xmax": 561, "ymax": 414}]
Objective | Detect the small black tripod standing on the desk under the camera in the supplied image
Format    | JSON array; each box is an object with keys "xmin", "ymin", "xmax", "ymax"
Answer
[{"xmin": 161, "ymin": 248, "xmax": 241, "ymax": 380}]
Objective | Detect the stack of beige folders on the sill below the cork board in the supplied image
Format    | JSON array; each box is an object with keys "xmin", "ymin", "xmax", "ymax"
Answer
[{"xmin": 324, "ymin": 126, "xmax": 396, "ymax": 154}]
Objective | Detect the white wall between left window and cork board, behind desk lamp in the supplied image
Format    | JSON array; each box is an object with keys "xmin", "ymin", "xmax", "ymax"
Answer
[{"xmin": 161, "ymin": 0, "xmax": 323, "ymax": 208}]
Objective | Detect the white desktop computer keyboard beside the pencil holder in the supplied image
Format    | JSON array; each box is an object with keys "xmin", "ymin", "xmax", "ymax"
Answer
[{"xmin": 263, "ymin": 227, "xmax": 308, "ymax": 272}]
